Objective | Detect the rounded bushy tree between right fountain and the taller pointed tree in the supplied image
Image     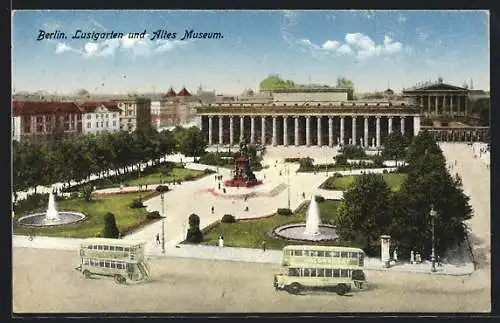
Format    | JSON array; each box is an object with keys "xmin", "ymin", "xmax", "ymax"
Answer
[{"xmin": 336, "ymin": 174, "xmax": 391, "ymax": 255}]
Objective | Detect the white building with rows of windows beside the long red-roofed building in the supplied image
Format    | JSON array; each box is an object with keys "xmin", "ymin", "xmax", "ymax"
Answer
[{"xmin": 80, "ymin": 102, "xmax": 121, "ymax": 135}]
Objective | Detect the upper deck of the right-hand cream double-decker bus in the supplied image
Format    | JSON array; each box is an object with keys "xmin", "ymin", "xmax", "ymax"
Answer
[{"xmin": 282, "ymin": 245, "xmax": 365, "ymax": 267}]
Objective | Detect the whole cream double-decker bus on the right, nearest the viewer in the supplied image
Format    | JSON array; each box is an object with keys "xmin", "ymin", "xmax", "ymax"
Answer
[{"xmin": 274, "ymin": 245, "xmax": 366, "ymax": 295}]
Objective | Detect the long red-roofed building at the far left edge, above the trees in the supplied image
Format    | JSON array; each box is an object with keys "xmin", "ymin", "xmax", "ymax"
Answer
[{"xmin": 12, "ymin": 101, "xmax": 83, "ymax": 140}]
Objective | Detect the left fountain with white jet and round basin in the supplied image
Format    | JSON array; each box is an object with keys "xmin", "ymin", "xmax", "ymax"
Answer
[{"xmin": 17, "ymin": 191, "xmax": 85, "ymax": 227}]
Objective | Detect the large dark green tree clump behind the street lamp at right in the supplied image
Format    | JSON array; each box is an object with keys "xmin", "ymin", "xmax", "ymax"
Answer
[{"xmin": 336, "ymin": 131, "xmax": 472, "ymax": 258}]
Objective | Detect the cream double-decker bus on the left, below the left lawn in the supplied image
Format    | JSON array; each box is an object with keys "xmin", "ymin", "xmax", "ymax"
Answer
[{"xmin": 78, "ymin": 238, "xmax": 150, "ymax": 284}]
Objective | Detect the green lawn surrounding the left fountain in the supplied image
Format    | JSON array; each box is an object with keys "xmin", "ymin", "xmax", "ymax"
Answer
[{"xmin": 14, "ymin": 193, "xmax": 158, "ymax": 238}]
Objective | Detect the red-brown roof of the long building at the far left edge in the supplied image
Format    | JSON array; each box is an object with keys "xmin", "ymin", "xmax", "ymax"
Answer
[{"xmin": 12, "ymin": 101, "xmax": 83, "ymax": 116}]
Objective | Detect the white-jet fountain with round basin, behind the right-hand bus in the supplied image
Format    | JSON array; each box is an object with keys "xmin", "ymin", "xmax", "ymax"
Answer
[{"xmin": 273, "ymin": 196, "xmax": 338, "ymax": 241}]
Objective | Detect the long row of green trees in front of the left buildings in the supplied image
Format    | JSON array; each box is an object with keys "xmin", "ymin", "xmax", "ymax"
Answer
[{"xmin": 13, "ymin": 127, "xmax": 206, "ymax": 192}]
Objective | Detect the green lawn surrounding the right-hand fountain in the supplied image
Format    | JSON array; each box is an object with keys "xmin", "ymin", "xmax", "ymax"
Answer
[{"xmin": 202, "ymin": 200, "xmax": 341, "ymax": 249}]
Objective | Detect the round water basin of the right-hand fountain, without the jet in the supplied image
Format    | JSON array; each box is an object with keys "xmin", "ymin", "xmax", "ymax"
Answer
[{"xmin": 273, "ymin": 223, "xmax": 338, "ymax": 242}]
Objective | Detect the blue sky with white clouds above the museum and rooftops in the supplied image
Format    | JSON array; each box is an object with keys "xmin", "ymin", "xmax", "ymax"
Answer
[{"xmin": 12, "ymin": 10, "xmax": 490, "ymax": 94}]
